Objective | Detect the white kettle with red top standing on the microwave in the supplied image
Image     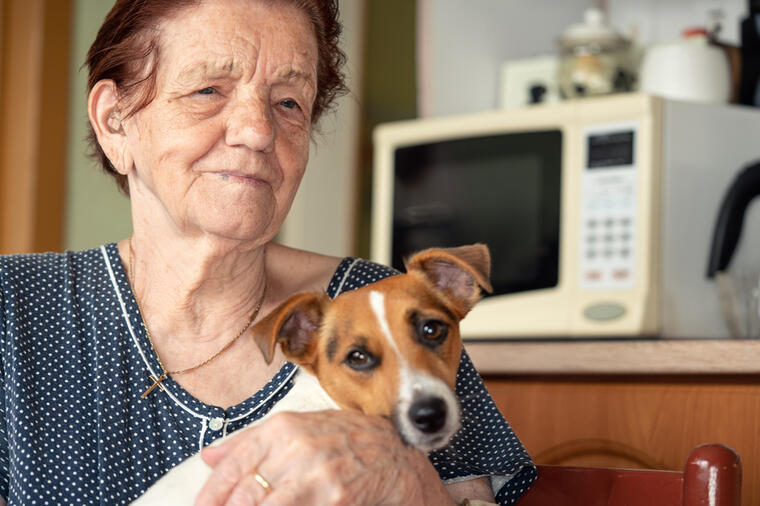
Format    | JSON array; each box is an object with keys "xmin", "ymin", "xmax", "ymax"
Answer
[{"xmin": 640, "ymin": 29, "xmax": 731, "ymax": 103}]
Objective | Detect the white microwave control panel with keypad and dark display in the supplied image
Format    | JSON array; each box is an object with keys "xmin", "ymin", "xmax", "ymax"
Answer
[{"xmin": 579, "ymin": 123, "xmax": 638, "ymax": 290}]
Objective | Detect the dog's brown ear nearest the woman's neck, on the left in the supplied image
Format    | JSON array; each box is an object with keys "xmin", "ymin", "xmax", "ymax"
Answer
[{"xmin": 251, "ymin": 293, "xmax": 330, "ymax": 365}]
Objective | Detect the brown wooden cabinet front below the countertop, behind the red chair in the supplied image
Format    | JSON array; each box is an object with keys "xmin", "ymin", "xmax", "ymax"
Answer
[{"xmin": 468, "ymin": 343, "xmax": 760, "ymax": 506}]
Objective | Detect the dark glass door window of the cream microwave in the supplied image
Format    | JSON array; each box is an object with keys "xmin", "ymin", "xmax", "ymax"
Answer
[{"xmin": 392, "ymin": 130, "xmax": 562, "ymax": 295}]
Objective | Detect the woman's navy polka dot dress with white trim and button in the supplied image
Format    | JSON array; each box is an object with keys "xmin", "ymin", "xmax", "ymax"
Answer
[{"xmin": 0, "ymin": 244, "xmax": 535, "ymax": 505}]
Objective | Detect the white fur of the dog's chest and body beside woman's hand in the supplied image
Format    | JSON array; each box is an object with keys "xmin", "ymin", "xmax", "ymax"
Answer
[{"xmin": 132, "ymin": 370, "xmax": 340, "ymax": 506}]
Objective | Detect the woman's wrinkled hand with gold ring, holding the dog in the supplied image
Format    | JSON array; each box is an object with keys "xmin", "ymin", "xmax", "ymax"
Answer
[{"xmin": 196, "ymin": 411, "xmax": 454, "ymax": 506}]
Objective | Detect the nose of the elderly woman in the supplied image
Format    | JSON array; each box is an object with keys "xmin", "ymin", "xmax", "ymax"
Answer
[{"xmin": 225, "ymin": 98, "xmax": 274, "ymax": 151}]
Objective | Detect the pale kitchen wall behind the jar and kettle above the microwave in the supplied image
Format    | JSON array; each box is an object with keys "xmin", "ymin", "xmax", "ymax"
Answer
[{"xmin": 417, "ymin": 0, "xmax": 747, "ymax": 116}]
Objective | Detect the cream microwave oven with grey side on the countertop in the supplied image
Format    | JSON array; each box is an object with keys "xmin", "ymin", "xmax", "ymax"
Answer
[{"xmin": 371, "ymin": 93, "xmax": 760, "ymax": 339}]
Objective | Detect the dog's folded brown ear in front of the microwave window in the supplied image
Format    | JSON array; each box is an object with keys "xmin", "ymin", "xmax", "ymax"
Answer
[{"xmin": 406, "ymin": 244, "xmax": 493, "ymax": 317}]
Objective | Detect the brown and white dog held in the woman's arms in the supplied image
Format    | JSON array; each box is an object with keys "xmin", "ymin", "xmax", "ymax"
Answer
[{"xmin": 132, "ymin": 244, "xmax": 492, "ymax": 506}]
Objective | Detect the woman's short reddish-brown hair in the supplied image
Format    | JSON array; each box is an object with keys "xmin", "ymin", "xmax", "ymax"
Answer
[{"xmin": 85, "ymin": 0, "xmax": 347, "ymax": 195}]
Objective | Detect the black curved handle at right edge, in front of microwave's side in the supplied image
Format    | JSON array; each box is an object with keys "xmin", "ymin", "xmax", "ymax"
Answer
[{"xmin": 707, "ymin": 163, "xmax": 760, "ymax": 278}]
